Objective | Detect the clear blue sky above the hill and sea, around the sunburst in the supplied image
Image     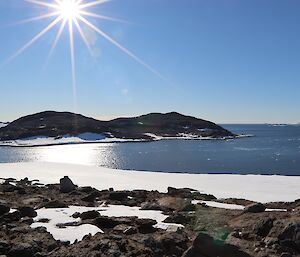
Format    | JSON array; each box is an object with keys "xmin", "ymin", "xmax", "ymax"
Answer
[{"xmin": 0, "ymin": 0, "xmax": 300, "ymax": 123}]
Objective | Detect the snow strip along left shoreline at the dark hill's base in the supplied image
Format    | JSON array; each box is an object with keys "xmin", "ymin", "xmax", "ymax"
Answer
[{"xmin": 0, "ymin": 132, "xmax": 143, "ymax": 146}]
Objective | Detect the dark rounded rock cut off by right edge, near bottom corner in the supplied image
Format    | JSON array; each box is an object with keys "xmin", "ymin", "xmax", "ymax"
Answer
[{"xmin": 278, "ymin": 222, "xmax": 300, "ymax": 252}]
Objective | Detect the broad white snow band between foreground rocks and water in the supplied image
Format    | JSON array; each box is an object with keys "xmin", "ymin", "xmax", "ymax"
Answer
[{"xmin": 0, "ymin": 162, "xmax": 300, "ymax": 202}]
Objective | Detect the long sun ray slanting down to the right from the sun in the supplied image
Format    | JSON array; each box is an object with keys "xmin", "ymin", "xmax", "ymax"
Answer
[{"xmin": 78, "ymin": 16, "xmax": 167, "ymax": 81}]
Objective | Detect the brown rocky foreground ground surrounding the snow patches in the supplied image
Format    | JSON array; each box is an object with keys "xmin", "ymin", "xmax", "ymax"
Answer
[{"xmin": 0, "ymin": 177, "xmax": 300, "ymax": 257}]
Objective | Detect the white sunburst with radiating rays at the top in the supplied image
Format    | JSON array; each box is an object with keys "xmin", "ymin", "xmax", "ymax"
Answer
[{"xmin": 6, "ymin": 0, "xmax": 165, "ymax": 106}]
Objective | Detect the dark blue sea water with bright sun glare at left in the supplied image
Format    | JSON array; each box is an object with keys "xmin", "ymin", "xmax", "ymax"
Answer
[{"xmin": 0, "ymin": 125, "xmax": 300, "ymax": 175}]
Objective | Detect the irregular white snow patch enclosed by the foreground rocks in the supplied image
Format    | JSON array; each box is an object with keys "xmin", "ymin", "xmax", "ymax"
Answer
[{"xmin": 31, "ymin": 205, "xmax": 183, "ymax": 243}]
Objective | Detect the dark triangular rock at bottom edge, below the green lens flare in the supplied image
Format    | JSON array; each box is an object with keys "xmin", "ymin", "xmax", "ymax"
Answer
[{"xmin": 182, "ymin": 233, "xmax": 251, "ymax": 257}]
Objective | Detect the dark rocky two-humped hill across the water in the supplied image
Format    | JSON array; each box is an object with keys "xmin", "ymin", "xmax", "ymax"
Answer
[{"xmin": 0, "ymin": 111, "xmax": 235, "ymax": 141}]
